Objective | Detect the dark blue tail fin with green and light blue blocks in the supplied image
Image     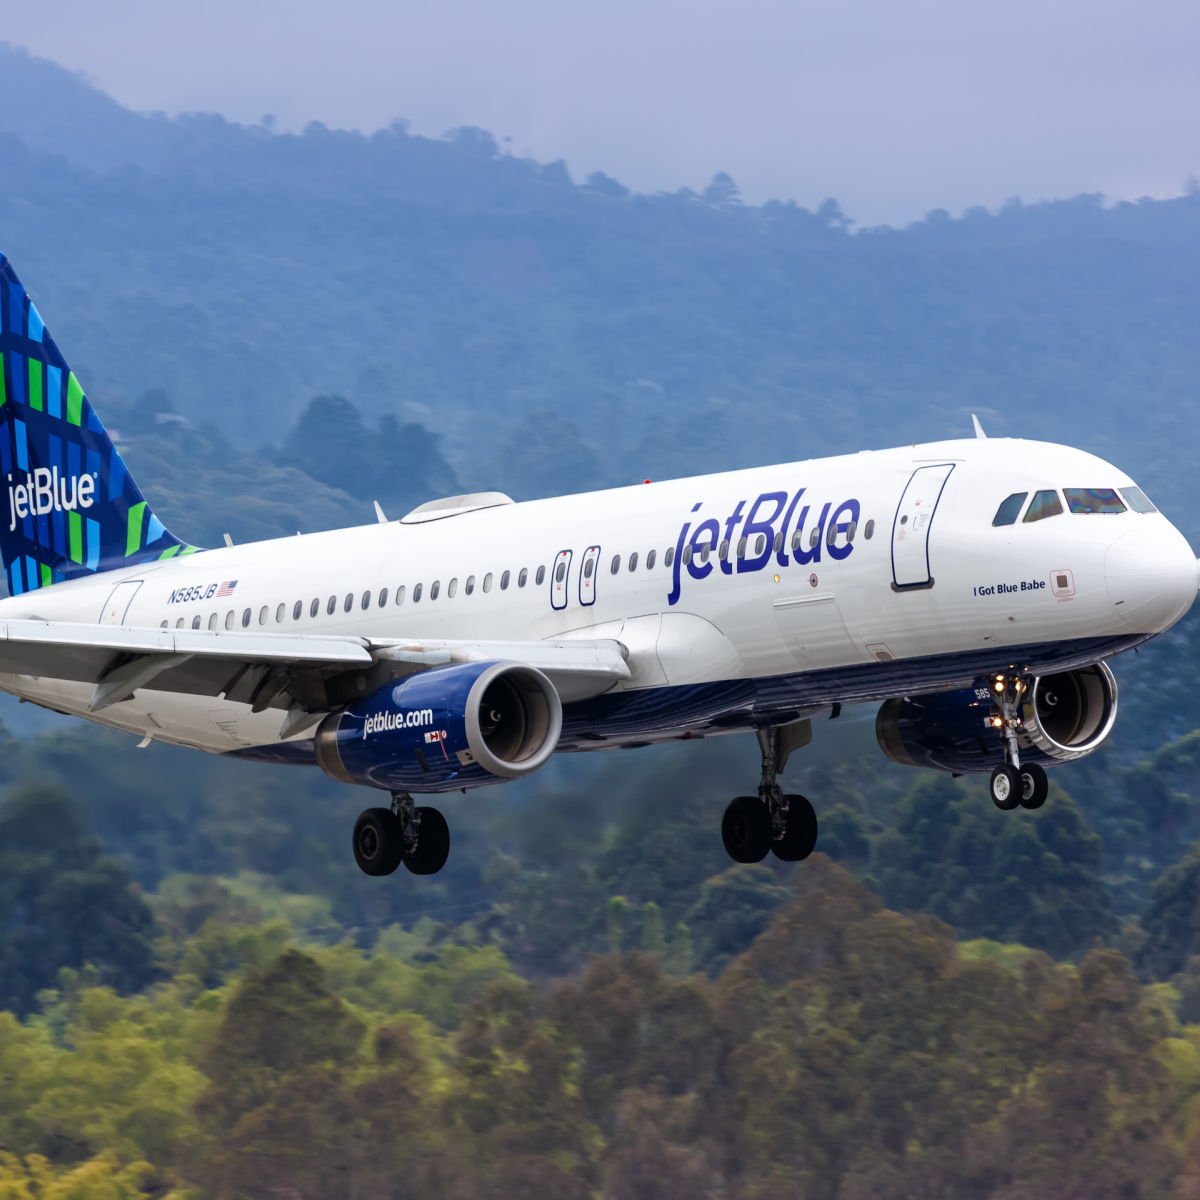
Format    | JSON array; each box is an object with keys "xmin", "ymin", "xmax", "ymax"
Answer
[{"xmin": 0, "ymin": 254, "xmax": 196, "ymax": 595}]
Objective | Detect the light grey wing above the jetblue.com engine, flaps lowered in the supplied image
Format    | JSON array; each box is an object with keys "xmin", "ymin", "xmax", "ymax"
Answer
[{"xmin": 0, "ymin": 620, "xmax": 630, "ymax": 738}]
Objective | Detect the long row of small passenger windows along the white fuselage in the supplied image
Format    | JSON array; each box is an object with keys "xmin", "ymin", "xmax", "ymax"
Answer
[{"xmin": 161, "ymin": 521, "xmax": 875, "ymax": 630}]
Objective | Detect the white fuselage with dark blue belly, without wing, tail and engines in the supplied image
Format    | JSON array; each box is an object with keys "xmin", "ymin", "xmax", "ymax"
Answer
[{"xmin": 0, "ymin": 439, "xmax": 1196, "ymax": 751}]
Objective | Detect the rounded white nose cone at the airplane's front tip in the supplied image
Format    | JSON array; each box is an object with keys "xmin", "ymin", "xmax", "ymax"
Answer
[{"xmin": 1104, "ymin": 521, "xmax": 1200, "ymax": 634}]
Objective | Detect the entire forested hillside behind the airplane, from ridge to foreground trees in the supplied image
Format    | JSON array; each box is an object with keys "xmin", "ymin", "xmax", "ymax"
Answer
[{"xmin": 0, "ymin": 39, "xmax": 1200, "ymax": 1200}]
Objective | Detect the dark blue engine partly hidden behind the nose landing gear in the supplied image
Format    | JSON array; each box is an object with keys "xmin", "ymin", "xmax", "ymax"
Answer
[{"xmin": 875, "ymin": 662, "xmax": 1117, "ymax": 774}]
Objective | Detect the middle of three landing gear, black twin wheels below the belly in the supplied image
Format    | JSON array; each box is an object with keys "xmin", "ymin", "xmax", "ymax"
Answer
[{"xmin": 721, "ymin": 721, "xmax": 817, "ymax": 863}]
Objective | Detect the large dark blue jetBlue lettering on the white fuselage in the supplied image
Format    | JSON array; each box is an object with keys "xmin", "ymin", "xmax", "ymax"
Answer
[{"xmin": 667, "ymin": 487, "xmax": 862, "ymax": 605}]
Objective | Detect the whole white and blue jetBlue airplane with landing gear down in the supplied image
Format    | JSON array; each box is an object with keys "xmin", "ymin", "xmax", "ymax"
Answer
[{"xmin": 0, "ymin": 254, "xmax": 1198, "ymax": 876}]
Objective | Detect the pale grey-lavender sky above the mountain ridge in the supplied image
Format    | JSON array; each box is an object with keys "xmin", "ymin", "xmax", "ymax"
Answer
[{"xmin": 0, "ymin": 0, "xmax": 1200, "ymax": 224}]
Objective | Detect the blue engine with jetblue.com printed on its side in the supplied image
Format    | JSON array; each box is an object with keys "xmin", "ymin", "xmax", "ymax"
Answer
[{"xmin": 316, "ymin": 662, "xmax": 563, "ymax": 792}]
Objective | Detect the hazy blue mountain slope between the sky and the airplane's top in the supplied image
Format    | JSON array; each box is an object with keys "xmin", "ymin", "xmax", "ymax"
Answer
[{"xmin": 0, "ymin": 47, "xmax": 1200, "ymax": 537}]
